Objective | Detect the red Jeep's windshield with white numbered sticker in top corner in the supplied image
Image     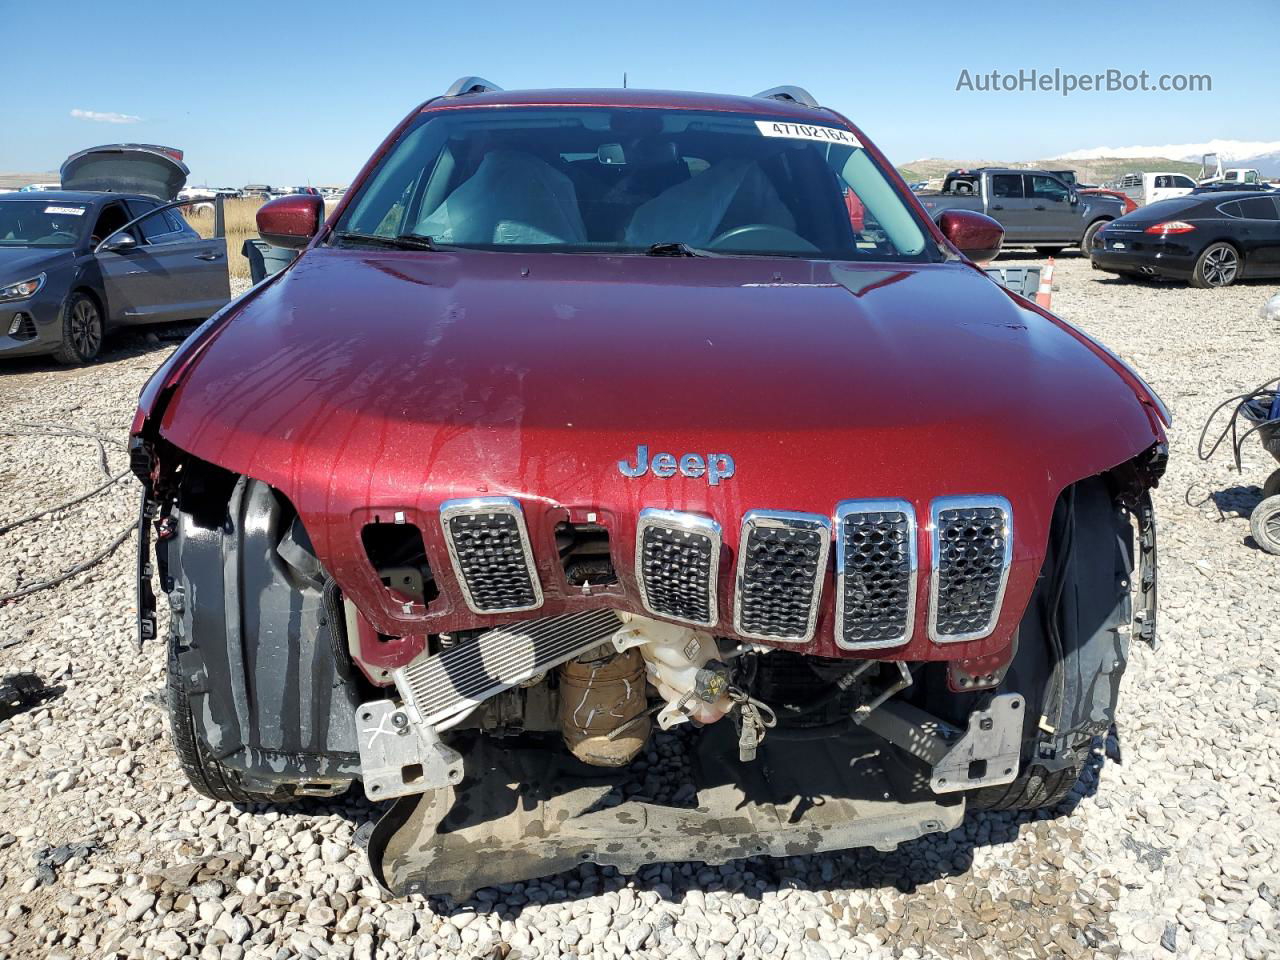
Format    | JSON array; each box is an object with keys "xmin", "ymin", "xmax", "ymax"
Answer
[{"xmin": 335, "ymin": 108, "xmax": 940, "ymax": 261}]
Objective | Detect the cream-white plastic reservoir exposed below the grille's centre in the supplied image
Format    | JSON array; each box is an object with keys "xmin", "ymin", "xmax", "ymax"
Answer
[{"xmin": 613, "ymin": 613, "xmax": 732, "ymax": 730}]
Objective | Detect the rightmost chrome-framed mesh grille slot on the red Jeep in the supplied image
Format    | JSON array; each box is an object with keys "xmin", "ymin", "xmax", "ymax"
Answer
[{"xmin": 929, "ymin": 494, "xmax": 1014, "ymax": 644}]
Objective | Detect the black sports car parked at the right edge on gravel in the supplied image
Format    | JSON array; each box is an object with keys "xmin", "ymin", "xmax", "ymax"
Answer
[{"xmin": 1089, "ymin": 189, "xmax": 1280, "ymax": 287}]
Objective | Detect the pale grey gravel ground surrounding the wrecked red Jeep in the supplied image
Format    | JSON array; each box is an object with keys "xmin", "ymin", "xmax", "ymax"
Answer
[{"xmin": 0, "ymin": 257, "xmax": 1280, "ymax": 960}]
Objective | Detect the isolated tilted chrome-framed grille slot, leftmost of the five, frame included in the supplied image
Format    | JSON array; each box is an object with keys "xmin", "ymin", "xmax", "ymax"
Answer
[{"xmin": 440, "ymin": 497, "xmax": 543, "ymax": 613}]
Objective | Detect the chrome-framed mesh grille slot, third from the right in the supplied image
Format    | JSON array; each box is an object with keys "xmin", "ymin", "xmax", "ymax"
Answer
[{"xmin": 733, "ymin": 509, "xmax": 831, "ymax": 644}]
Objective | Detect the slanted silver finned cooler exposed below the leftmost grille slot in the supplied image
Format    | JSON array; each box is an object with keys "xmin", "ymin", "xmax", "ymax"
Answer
[{"xmin": 393, "ymin": 611, "xmax": 622, "ymax": 723}]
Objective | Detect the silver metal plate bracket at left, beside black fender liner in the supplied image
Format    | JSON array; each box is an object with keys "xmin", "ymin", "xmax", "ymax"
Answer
[{"xmin": 356, "ymin": 700, "xmax": 462, "ymax": 800}]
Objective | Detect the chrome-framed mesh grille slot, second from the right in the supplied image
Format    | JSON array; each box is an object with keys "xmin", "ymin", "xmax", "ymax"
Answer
[{"xmin": 835, "ymin": 499, "xmax": 919, "ymax": 650}]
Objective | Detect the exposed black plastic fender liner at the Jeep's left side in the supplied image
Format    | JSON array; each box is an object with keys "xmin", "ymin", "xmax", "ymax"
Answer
[{"xmin": 156, "ymin": 477, "xmax": 360, "ymax": 788}]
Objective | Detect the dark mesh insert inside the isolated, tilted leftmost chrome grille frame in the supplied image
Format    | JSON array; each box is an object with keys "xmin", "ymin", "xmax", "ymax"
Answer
[{"xmin": 444, "ymin": 509, "xmax": 541, "ymax": 613}]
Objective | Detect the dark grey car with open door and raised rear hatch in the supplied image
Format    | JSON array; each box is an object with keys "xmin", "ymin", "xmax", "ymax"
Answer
[{"xmin": 0, "ymin": 143, "xmax": 230, "ymax": 364}]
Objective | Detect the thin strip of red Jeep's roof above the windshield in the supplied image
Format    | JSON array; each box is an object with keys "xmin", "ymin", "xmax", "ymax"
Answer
[{"xmin": 421, "ymin": 87, "xmax": 835, "ymax": 123}]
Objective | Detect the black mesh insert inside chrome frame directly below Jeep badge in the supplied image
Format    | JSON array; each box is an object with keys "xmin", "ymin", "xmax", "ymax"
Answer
[{"xmin": 639, "ymin": 525, "xmax": 718, "ymax": 625}]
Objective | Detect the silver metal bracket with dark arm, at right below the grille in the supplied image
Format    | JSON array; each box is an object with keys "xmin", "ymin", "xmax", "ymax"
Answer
[{"xmin": 863, "ymin": 694, "xmax": 1025, "ymax": 794}]
